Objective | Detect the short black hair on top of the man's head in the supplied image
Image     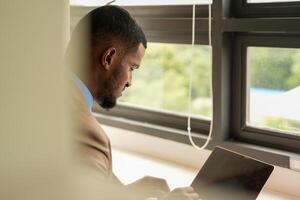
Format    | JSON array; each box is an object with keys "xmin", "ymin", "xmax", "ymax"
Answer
[{"xmin": 71, "ymin": 5, "xmax": 147, "ymax": 49}]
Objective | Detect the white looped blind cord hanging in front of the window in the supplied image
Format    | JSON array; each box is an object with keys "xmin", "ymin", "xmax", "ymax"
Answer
[{"xmin": 187, "ymin": 4, "xmax": 213, "ymax": 150}]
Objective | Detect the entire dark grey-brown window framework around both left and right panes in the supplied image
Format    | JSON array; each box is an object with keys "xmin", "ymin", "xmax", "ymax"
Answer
[{"xmin": 71, "ymin": 0, "xmax": 300, "ymax": 168}]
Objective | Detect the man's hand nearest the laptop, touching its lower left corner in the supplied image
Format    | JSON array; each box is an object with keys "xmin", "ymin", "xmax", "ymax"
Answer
[{"xmin": 160, "ymin": 187, "xmax": 200, "ymax": 200}]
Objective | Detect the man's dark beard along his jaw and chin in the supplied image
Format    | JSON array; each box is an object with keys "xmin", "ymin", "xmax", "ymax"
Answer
[{"xmin": 96, "ymin": 65, "xmax": 121, "ymax": 110}]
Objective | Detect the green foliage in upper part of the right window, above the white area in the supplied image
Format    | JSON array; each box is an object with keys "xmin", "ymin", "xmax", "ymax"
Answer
[{"xmin": 248, "ymin": 47, "xmax": 300, "ymax": 90}]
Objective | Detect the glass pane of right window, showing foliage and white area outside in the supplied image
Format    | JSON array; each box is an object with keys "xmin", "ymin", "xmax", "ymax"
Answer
[{"xmin": 247, "ymin": 47, "xmax": 300, "ymax": 134}]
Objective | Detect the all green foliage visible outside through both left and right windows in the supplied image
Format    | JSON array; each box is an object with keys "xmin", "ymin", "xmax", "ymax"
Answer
[{"xmin": 121, "ymin": 43, "xmax": 300, "ymax": 131}]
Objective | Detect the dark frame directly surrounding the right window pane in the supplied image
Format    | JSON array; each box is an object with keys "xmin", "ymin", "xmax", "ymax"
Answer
[{"xmin": 233, "ymin": 34, "xmax": 300, "ymax": 153}]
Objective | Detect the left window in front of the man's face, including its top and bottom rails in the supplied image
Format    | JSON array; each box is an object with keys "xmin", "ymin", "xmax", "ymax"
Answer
[{"xmin": 84, "ymin": 5, "xmax": 212, "ymax": 136}]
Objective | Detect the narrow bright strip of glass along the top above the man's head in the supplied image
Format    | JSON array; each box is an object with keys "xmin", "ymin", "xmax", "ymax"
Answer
[{"xmin": 70, "ymin": 0, "xmax": 212, "ymax": 6}]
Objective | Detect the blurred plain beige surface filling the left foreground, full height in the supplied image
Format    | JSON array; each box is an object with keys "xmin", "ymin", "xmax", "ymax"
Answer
[{"xmin": 0, "ymin": 0, "xmax": 70, "ymax": 200}]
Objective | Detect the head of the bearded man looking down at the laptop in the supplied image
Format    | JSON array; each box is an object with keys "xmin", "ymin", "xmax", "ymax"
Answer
[{"xmin": 70, "ymin": 6, "xmax": 147, "ymax": 109}]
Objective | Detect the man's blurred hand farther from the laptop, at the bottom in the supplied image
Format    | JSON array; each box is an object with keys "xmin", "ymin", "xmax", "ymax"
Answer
[{"xmin": 126, "ymin": 176, "xmax": 170, "ymax": 198}]
